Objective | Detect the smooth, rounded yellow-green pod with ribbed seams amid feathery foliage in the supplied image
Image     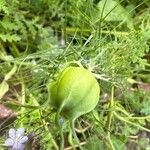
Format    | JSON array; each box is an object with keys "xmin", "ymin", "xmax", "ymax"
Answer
[{"xmin": 49, "ymin": 67, "xmax": 100, "ymax": 119}]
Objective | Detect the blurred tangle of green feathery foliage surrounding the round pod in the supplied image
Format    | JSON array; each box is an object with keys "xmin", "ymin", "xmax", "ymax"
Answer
[{"xmin": 0, "ymin": 0, "xmax": 150, "ymax": 150}]
